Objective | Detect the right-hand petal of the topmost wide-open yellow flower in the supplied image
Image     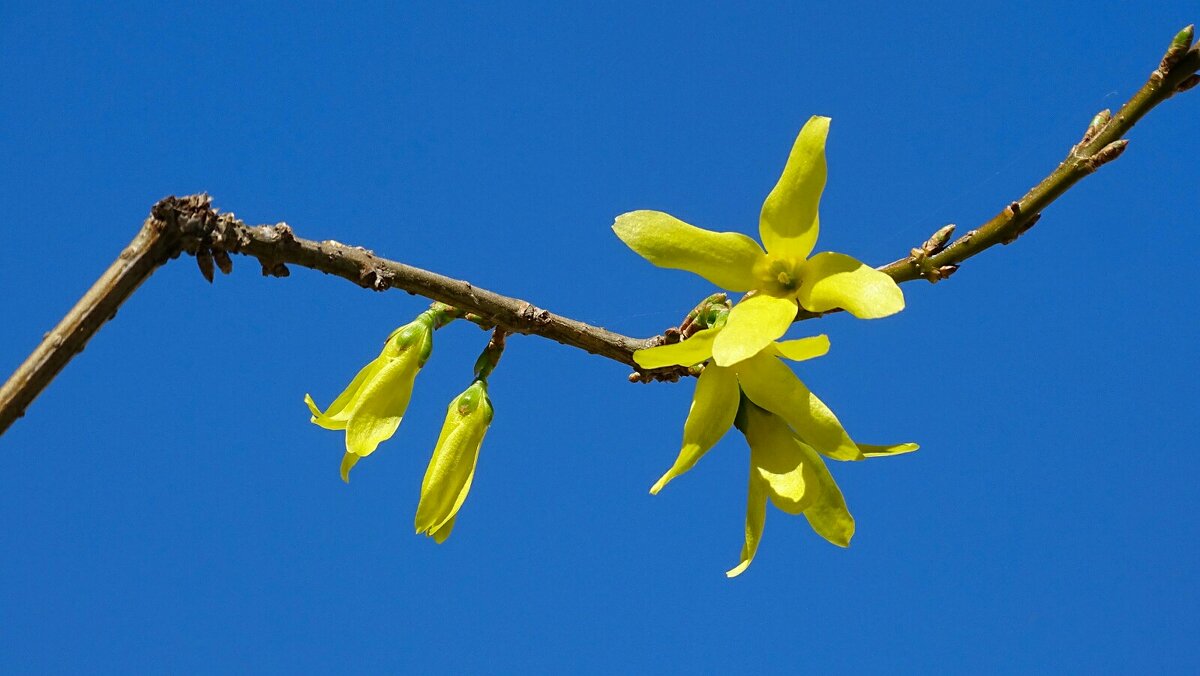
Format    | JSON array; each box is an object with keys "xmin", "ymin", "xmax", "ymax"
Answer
[{"xmin": 797, "ymin": 251, "xmax": 904, "ymax": 319}]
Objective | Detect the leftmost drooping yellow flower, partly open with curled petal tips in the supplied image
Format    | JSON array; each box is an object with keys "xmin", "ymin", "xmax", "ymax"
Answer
[{"xmin": 304, "ymin": 310, "xmax": 443, "ymax": 483}]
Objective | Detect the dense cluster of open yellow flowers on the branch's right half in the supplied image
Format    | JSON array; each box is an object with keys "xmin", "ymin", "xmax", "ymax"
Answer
[{"xmin": 613, "ymin": 116, "xmax": 917, "ymax": 578}]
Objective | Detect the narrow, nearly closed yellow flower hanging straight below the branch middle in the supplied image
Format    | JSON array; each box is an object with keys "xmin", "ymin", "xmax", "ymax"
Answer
[{"xmin": 415, "ymin": 381, "xmax": 492, "ymax": 544}]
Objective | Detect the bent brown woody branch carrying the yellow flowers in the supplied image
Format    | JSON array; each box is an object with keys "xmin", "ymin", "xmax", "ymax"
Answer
[{"xmin": 0, "ymin": 26, "xmax": 1200, "ymax": 435}]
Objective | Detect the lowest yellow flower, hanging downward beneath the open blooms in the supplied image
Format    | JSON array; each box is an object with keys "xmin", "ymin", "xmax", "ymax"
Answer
[{"xmin": 725, "ymin": 400, "xmax": 854, "ymax": 578}]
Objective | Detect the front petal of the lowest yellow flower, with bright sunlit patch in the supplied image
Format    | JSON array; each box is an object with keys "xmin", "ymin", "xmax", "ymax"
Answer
[{"xmin": 739, "ymin": 402, "xmax": 824, "ymax": 514}]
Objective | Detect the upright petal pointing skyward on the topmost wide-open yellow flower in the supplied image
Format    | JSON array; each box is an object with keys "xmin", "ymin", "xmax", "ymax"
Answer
[{"xmin": 758, "ymin": 115, "xmax": 829, "ymax": 259}]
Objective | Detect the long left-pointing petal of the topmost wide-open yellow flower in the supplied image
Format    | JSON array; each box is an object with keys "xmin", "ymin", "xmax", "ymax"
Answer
[{"xmin": 612, "ymin": 211, "xmax": 763, "ymax": 292}]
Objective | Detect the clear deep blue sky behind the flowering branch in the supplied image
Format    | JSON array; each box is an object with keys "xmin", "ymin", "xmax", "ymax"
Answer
[{"xmin": 0, "ymin": 1, "xmax": 1200, "ymax": 672}]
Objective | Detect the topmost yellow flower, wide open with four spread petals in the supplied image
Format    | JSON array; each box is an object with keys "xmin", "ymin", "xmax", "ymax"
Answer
[{"xmin": 613, "ymin": 116, "xmax": 904, "ymax": 366}]
